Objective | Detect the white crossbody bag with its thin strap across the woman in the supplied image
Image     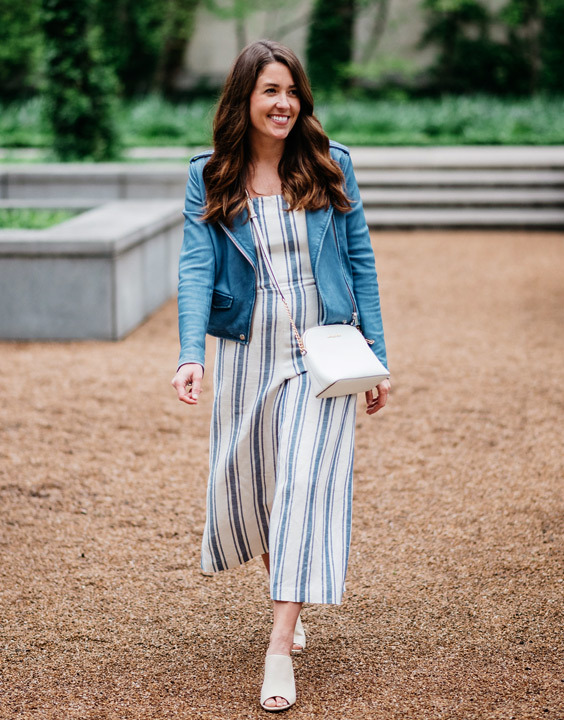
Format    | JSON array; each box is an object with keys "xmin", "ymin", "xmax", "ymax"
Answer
[{"xmin": 248, "ymin": 197, "xmax": 390, "ymax": 398}]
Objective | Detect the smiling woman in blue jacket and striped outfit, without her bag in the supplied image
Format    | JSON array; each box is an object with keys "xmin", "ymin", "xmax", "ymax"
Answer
[{"xmin": 172, "ymin": 41, "xmax": 390, "ymax": 711}]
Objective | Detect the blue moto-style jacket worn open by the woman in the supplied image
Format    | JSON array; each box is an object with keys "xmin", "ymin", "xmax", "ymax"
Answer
[{"xmin": 178, "ymin": 142, "xmax": 387, "ymax": 367}]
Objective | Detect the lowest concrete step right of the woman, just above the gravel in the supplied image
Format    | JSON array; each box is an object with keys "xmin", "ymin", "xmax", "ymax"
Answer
[{"xmin": 365, "ymin": 207, "xmax": 564, "ymax": 230}]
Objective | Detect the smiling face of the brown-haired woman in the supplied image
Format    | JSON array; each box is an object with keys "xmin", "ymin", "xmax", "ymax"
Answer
[{"xmin": 249, "ymin": 62, "xmax": 300, "ymax": 148}]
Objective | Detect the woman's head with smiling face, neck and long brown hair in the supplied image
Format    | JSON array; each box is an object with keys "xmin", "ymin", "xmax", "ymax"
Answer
[{"xmin": 196, "ymin": 41, "xmax": 351, "ymax": 227}]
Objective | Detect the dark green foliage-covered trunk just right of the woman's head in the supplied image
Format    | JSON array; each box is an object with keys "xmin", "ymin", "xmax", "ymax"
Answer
[{"xmin": 306, "ymin": 0, "xmax": 355, "ymax": 91}]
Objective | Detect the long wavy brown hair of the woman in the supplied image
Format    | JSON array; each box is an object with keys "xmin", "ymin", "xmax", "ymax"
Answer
[{"xmin": 202, "ymin": 40, "xmax": 351, "ymax": 227}]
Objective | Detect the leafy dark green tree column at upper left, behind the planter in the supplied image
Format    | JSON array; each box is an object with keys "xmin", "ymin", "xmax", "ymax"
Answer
[{"xmin": 42, "ymin": 0, "xmax": 118, "ymax": 160}]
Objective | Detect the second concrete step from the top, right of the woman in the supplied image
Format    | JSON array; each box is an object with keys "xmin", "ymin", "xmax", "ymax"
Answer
[{"xmin": 356, "ymin": 168, "xmax": 564, "ymax": 188}]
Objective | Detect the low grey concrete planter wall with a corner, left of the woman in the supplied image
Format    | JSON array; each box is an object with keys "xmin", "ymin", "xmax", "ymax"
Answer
[{"xmin": 0, "ymin": 201, "xmax": 183, "ymax": 340}]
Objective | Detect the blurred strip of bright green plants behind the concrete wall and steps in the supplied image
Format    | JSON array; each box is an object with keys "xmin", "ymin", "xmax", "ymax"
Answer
[{"xmin": 0, "ymin": 95, "xmax": 564, "ymax": 149}]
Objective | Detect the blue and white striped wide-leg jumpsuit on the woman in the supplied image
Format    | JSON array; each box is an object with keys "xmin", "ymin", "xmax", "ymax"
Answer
[{"xmin": 202, "ymin": 195, "xmax": 356, "ymax": 604}]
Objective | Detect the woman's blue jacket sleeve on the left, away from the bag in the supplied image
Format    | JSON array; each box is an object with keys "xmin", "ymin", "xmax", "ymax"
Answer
[{"xmin": 178, "ymin": 162, "xmax": 215, "ymax": 367}]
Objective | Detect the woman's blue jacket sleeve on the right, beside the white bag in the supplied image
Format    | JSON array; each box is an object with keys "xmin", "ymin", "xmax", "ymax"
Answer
[{"xmin": 341, "ymin": 153, "xmax": 388, "ymax": 367}]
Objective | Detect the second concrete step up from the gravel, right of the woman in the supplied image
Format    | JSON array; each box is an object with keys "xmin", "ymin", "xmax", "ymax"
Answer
[{"xmin": 361, "ymin": 187, "xmax": 564, "ymax": 209}]
